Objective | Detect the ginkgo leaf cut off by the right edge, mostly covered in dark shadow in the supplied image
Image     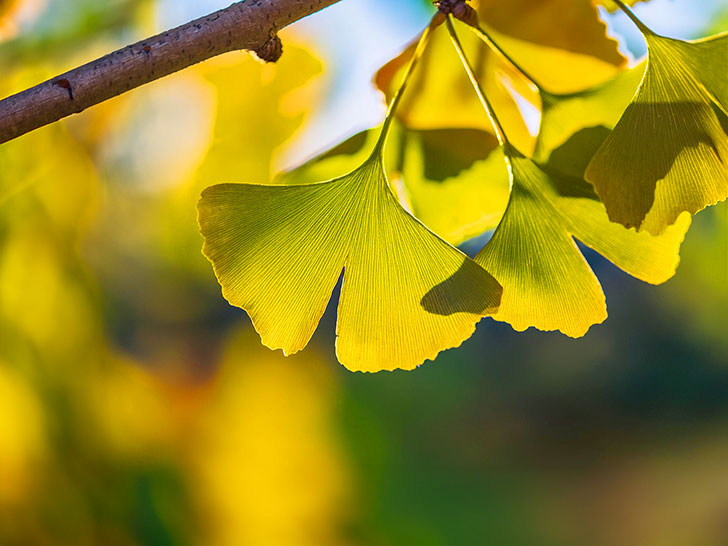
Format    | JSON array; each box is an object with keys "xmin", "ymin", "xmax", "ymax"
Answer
[{"xmin": 586, "ymin": 20, "xmax": 728, "ymax": 234}]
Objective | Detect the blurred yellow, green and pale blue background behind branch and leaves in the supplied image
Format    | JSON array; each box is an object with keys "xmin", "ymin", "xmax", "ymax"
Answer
[{"xmin": 0, "ymin": 0, "xmax": 728, "ymax": 546}]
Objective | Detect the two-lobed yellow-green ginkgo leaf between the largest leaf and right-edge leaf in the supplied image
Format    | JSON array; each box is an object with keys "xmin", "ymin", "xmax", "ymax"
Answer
[{"xmin": 475, "ymin": 144, "xmax": 690, "ymax": 337}]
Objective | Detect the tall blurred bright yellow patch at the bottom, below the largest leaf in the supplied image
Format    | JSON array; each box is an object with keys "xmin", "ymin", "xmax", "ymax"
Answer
[{"xmin": 188, "ymin": 329, "xmax": 349, "ymax": 546}]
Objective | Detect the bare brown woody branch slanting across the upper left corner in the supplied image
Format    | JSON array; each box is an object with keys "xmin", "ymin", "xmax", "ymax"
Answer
[{"xmin": 0, "ymin": 0, "xmax": 339, "ymax": 144}]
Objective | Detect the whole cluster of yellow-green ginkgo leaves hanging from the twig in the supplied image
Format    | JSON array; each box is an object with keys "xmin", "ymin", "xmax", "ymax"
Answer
[{"xmin": 199, "ymin": 0, "xmax": 728, "ymax": 371}]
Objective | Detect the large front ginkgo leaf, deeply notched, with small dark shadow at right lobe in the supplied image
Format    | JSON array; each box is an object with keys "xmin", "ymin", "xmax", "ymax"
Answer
[{"xmin": 199, "ymin": 154, "xmax": 501, "ymax": 371}]
